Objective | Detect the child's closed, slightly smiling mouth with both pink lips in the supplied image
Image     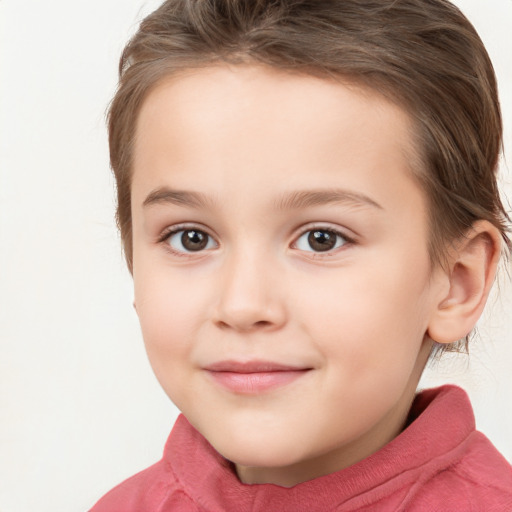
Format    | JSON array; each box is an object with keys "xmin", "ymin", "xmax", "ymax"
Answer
[{"xmin": 204, "ymin": 361, "xmax": 312, "ymax": 395}]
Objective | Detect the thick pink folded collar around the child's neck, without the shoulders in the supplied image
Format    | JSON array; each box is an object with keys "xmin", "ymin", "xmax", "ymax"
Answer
[{"xmin": 164, "ymin": 385, "xmax": 475, "ymax": 512}]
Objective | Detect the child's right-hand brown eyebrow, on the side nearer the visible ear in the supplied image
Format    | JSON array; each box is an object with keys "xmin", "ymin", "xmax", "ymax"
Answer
[{"xmin": 275, "ymin": 189, "xmax": 383, "ymax": 210}]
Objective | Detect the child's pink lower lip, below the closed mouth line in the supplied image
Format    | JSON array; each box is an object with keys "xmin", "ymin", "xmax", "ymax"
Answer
[{"xmin": 208, "ymin": 370, "xmax": 309, "ymax": 395}]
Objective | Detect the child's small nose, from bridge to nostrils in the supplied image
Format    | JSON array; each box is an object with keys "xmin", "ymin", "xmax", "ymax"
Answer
[{"xmin": 214, "ymin": 251, "xmax": 287, "ymax": 332}]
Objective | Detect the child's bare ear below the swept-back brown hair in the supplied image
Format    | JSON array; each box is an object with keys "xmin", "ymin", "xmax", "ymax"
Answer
[{"xmin": 427, "ymin": 220, "xmax": 501, "ymax": 343}]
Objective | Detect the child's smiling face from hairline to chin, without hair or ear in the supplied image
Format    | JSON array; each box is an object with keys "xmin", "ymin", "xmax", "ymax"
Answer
[{"xmin": 132, "ymin": 65, "xmax": 446, "ymax": 486}]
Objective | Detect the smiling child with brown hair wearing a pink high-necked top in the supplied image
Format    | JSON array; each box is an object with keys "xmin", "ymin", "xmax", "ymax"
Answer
[{"xmin": 92, "ymin": 0, "xmax": 512, "ymax": 512}]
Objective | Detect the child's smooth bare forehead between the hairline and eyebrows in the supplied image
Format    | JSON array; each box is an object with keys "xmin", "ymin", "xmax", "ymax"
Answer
[{"xmin": 132, "ymin": 65, "xmax": 424, "ymax": 214}]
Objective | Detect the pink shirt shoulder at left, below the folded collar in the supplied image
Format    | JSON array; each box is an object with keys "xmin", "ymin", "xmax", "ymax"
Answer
[{"xmin": 89, "ymin": 460, "xmax": 197, "ymax": 512}]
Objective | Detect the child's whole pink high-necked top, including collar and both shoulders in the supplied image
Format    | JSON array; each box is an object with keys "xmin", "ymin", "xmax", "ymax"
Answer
[{"xmin": 91, "ymin": 386, "xmax": 512, "ymax": 512}]
